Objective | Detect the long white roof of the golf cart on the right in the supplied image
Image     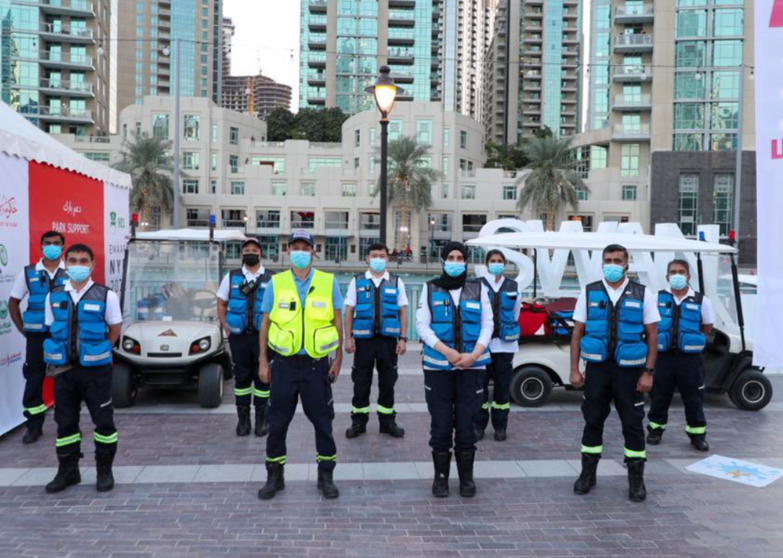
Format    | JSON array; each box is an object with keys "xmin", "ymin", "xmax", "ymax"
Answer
[{"xmin": 468, "ymin": 232, "xmax": 737, "ymax": 254}]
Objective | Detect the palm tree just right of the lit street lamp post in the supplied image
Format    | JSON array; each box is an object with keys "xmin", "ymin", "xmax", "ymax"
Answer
[{"xmin": 375, "ymin": 136, "xmax": 442, "ymax": 250}]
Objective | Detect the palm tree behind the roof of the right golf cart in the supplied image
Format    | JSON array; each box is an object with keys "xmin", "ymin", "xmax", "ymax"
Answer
[{"xmin": 516, "ymin": 136, "xmax": 587, "ymax": 230}]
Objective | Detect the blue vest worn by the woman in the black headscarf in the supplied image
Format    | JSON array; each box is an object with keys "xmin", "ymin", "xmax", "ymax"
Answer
[{"xmin": 422, "ymin": 280, "xmax": 491, "ymax": 370}]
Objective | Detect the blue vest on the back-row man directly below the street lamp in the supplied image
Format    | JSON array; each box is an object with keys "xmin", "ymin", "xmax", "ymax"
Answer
[{"xmin": 351, "ymin": 275, "xmax": 402, "ymax": 339}]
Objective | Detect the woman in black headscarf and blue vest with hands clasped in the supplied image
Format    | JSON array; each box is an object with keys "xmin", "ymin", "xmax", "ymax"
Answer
[{"xmin": 416, "ymin": 242, "xmax": 494, "ymax": 498}]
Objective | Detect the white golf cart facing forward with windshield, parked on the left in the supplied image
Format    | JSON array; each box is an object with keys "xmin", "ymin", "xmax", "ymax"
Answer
[{"xmin": 112, "ymin": 224, "xmax": 245, "ymax": 408}]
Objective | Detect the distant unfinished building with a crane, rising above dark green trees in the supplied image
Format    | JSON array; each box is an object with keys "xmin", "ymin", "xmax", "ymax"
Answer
[{"xmin": 222, "ymin": 74, "xmax": 291, "ymax": 120}]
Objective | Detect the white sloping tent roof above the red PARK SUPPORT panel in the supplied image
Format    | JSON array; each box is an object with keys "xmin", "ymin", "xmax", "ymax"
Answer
[{"xmin": 0, "ymin": 102, "xmax": 131, "ymax": 188}]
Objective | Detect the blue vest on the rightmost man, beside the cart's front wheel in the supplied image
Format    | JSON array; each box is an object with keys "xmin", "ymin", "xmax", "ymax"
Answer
[{"xmin": 658, "ymin": 291, "xmax": 707, "ymax": 354}]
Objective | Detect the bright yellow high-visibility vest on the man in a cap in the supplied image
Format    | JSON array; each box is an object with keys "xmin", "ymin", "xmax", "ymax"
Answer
[{"xmin": 268, "ymin": 270, "xmax": 340, "ymax": 358}]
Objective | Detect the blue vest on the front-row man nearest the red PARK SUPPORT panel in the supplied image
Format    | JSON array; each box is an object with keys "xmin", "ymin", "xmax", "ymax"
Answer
[{"xmin": 44, "ymin": 284, "xmax": 112, "ymax": 367}]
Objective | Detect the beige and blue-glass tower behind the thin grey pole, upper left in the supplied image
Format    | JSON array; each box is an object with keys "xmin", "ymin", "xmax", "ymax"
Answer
[{"xmin": 118, "ymin": 0, "xmax": 223, "ymax": 118}]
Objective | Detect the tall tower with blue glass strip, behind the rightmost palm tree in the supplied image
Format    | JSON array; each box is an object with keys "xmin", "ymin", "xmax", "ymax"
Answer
[{"xmin": 483, "ymin": 0, "xmax": 582, "ymax": 144}]
